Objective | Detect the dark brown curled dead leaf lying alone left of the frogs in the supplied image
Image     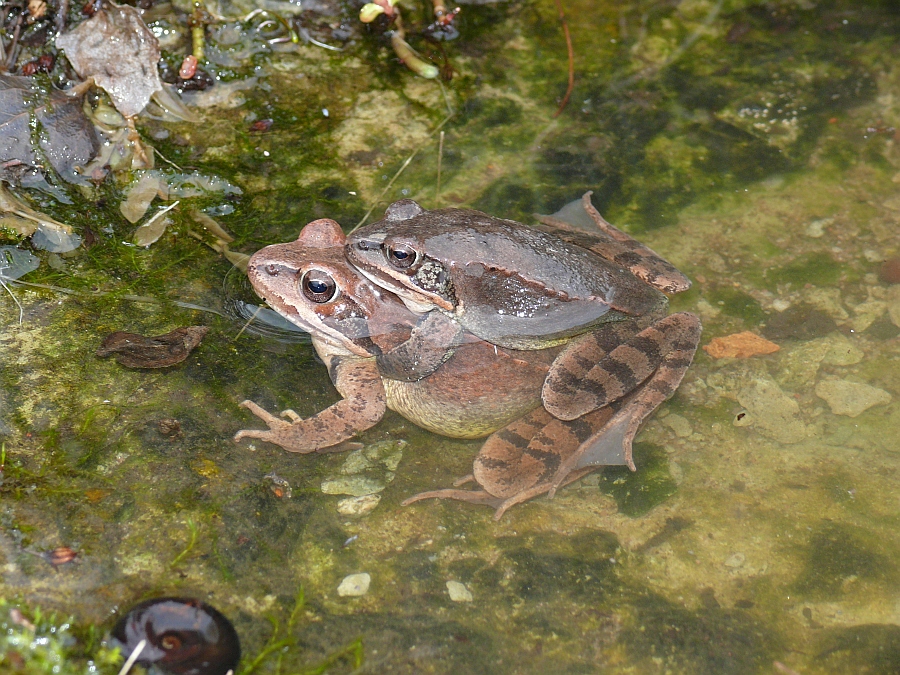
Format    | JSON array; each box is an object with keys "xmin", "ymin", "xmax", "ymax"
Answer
[{"xmin": 97, "ymin": 326, "xmax": 209, "ymax": 368}]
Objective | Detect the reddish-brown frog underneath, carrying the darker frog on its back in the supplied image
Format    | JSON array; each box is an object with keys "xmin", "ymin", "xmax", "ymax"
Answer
[{"xmin": 235, "ymin": 219, "xmax": 623, "ymax": 518}]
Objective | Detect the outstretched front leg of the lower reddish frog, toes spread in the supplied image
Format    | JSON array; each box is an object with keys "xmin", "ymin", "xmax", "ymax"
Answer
[{"xmin": 234, "ymin": 356, "xmax": 387, "ymax": 453}]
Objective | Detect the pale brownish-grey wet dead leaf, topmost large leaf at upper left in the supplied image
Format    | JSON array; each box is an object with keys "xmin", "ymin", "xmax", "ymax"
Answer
[{"xmin": 56, "ymin": 2, "xmax": 163, "ymax": 117}]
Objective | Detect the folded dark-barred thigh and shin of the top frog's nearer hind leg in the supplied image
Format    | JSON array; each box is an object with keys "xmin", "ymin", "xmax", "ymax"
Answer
[{"xmin": 542, "ymin": 312, "xmax": 701, "ymax": 420}]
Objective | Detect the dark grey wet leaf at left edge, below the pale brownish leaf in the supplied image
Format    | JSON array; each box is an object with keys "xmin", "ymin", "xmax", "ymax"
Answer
[{"xmin": 0, "ymin": 74, "xmax": 99, "ymax": 182}]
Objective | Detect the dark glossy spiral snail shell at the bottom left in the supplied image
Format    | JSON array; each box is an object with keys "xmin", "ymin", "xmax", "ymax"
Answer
[{"xmin": 110, "ymin": 598, "xmax": 241, "ymax": 675}]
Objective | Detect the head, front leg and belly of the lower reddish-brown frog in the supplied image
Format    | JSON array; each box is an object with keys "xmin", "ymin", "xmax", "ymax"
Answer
[{"xmin": 235, "ymin": 219, "xmax": 558, "ymax": 453}]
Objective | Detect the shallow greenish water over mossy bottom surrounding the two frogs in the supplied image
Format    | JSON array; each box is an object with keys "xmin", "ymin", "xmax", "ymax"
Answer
[{"xmin": 0, "ymin": 0, "xmax": 900, "ymax": 673}]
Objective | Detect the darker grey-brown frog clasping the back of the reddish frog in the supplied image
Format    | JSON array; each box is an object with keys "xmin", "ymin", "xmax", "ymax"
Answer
[{"xmin": 346, "ymin": 192, "xmax": 701, "ymax": 472}]
